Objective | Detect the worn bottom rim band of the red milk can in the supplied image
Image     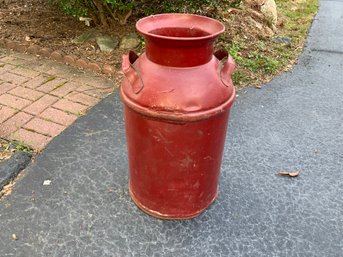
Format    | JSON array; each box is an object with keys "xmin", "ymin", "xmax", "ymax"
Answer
[{"xmin": 129, "ymin": 185, "xmax": 218, "ymax": 220}]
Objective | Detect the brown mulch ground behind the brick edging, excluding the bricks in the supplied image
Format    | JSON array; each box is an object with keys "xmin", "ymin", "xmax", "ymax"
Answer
[{"xmin": 0, "ymin": 0, "xmax": 135, "ymax": 68}]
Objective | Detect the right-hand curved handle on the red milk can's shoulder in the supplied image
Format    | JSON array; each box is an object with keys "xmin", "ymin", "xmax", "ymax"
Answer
[{"xmin": 214, "ymin": 49, "xmax": 236, "ymax": 87}]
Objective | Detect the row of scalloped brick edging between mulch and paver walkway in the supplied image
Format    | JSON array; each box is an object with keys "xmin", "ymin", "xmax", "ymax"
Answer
[{"xmin": 0, "ymin": 39, "xmax": 116, "ymax": 76}]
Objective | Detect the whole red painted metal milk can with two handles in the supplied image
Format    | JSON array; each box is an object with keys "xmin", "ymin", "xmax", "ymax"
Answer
[{"xmin": 120, "ymin": 14, "xmax": 235, "ymax": 219}]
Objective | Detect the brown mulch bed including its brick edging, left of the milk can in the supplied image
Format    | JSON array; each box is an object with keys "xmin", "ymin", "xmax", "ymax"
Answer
[{"xmin": 0, "ymin": 0, "xmax": 135, "ymax": 75}]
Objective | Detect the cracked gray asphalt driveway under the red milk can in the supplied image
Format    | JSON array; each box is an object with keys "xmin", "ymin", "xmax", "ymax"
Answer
[{"xmin": 0, "ymin": 1, "xmax": 343, "ymax": 257}]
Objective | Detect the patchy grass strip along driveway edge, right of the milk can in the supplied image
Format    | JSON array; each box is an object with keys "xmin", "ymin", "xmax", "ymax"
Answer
[{"xmin": 226, "ymin": 0, "xmax": 318, "ymax": 86}]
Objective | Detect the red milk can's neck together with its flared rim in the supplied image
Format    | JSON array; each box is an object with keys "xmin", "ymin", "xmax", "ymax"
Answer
[{"xmin": 136, "ymin": 13, "xmax": 225, "ymax": 67}]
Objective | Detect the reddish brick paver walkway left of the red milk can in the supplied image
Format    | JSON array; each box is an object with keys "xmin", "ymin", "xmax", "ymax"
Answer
[{"xmin": 0, "ymin": 49, "xmax": 115, "ymax": 151}]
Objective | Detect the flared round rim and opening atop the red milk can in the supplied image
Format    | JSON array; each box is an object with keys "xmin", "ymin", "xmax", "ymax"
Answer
[{"xmin": 136, "ymin": 13, "xmax": 225, "ymax": 41}]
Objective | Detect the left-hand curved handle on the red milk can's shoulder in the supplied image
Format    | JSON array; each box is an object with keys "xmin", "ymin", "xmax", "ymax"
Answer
[{"xmin": 121, "ymin": 51, "xmax": 144, "ymax": 94}]
